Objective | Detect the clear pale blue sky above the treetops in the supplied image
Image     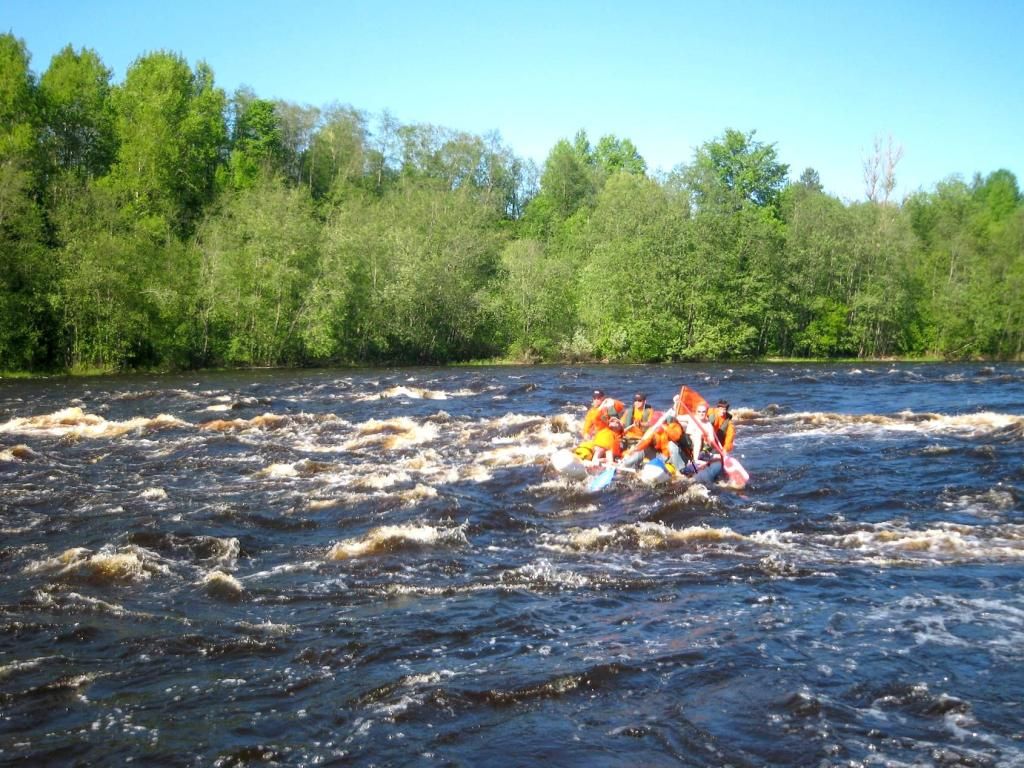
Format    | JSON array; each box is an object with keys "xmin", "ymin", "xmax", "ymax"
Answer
[{"xmin": 8, "ymin": 0, "xmax": 1024, "ymax": 200}]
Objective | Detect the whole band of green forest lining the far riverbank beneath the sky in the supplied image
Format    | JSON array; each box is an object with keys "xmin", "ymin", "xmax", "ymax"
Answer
[{"xmin": 0, "ymin": 33, "xmax": 1024, "ymax": 373}]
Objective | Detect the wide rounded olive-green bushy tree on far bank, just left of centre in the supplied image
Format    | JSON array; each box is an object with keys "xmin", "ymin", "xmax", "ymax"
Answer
[{"xmin": 327, "ymin": 180, "xmax": 501, "ymax": 362}]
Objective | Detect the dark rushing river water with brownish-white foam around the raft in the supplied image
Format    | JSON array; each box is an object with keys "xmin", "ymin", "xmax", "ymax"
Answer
[{"xmin": 0, "ymin": 364, "xmax": 1024, "ymax": 767}]
